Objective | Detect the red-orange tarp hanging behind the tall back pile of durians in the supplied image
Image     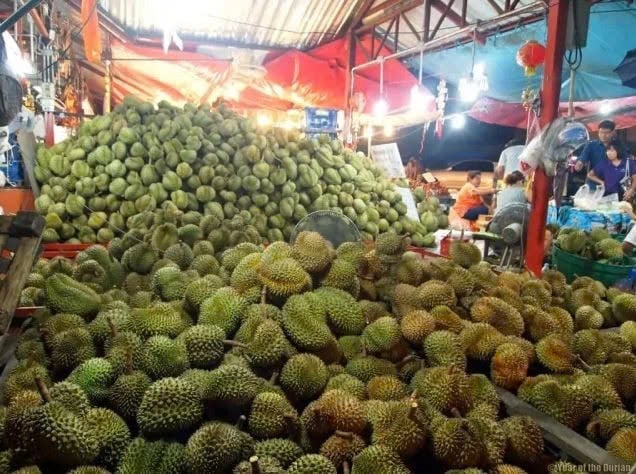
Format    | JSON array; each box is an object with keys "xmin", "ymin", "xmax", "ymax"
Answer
[{"xmin": 95, "ymin": 37, "xmax": 428, "ymax": 110}]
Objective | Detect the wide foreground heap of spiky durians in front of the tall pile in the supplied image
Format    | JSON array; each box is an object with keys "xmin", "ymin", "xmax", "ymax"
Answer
[{"xmin": 0, "ymin": 232, "xmax": 636, "ymax": 474}]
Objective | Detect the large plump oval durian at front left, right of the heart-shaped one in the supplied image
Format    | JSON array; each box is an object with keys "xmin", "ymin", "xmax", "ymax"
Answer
[{"xmin": 137, "ymin": 377, "xmax": 203, "ymax": 436}]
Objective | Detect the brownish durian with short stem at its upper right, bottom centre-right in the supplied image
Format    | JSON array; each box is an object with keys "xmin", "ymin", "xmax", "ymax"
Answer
[{"xmin": 371, "ymin": 400, "xmax": 427, "ymax": 459}]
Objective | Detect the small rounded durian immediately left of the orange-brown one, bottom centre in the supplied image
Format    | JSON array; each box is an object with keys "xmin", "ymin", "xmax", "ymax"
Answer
[{"xmin": 248, "ymin": 392, "xmax": 298, "ymax": 439}]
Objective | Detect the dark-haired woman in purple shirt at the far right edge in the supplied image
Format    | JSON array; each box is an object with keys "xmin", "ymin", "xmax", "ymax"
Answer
[{"xmin": 587, "ymin": 141, "xmax": 636, "ymax": 201}]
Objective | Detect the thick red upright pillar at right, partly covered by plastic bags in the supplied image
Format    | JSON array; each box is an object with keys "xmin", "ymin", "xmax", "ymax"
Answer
[{"xmin": 525, "ymin": 0, "xmax": 569, "ymax": 276}]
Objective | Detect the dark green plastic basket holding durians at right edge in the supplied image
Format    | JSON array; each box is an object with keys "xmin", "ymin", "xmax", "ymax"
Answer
[{"xmin": 552, "ymin": 245, "xmax": 636, "ymax": 287}]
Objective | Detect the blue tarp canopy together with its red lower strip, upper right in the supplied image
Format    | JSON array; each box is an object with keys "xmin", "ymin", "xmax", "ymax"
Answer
[{"xmin": 409, "ymin": 2, "xmax": 636, "ymax": 128}]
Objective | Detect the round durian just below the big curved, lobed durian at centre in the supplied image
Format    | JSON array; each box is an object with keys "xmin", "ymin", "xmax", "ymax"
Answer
[{"xmin": 280, "ymin": 354, "xmax": 327, "ymax": 400}]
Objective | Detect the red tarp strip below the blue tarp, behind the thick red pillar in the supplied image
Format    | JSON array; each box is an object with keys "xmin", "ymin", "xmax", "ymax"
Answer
[{"xmin": 470, "ymin": 97, "xmax": 636, "ymax": 131}]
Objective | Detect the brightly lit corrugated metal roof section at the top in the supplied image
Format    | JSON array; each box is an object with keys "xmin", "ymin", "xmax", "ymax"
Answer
[{"xmin": 100, "ymin": 0, "xmax": 363, "ymax": 49}]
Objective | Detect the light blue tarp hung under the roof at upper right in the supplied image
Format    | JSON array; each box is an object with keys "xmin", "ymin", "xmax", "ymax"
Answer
[{"xmin": 409, "ymin": 1, "xmax": 636, "ymax": 102}]
